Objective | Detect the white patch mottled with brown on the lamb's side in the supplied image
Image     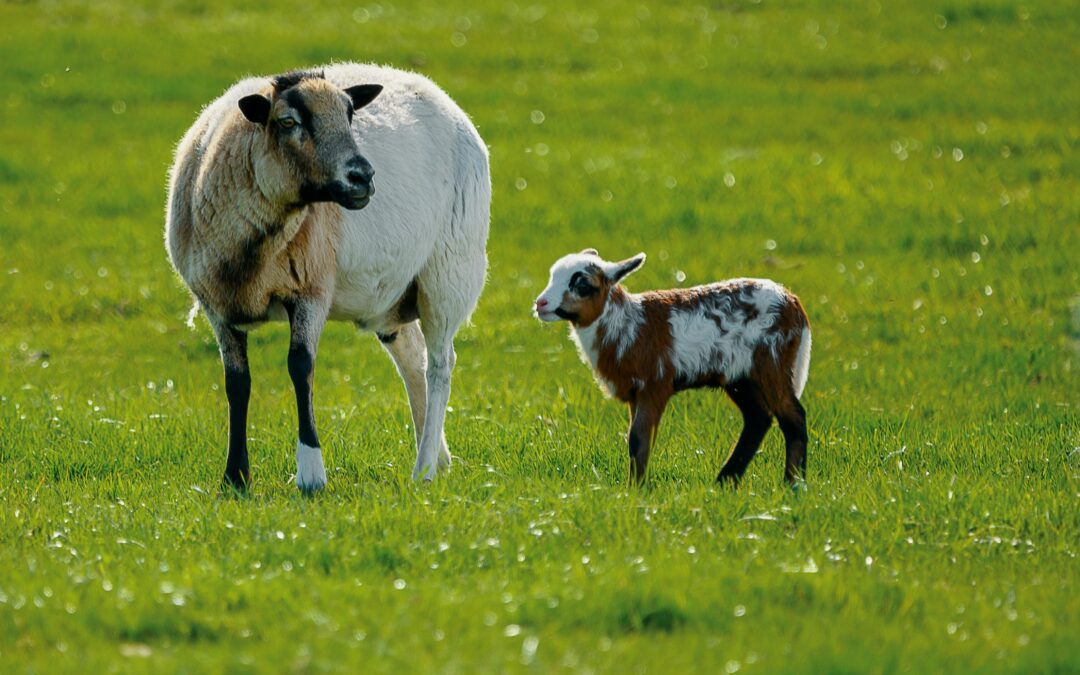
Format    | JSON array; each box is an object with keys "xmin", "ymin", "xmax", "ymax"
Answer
[{"xmin": 669, "ymin": 279, "xmax": 784, "ymax": 380}]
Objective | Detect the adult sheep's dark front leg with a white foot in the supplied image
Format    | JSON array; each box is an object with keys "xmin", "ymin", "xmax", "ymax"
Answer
[{"xmin": 285, "ymin": 298, "xmax": 329, "ymax": 492}]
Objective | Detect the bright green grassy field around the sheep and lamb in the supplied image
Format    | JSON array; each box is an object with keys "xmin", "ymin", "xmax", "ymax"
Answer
[{"xmin": 0, "ymin": 0, "xmax": 1080, "ymax": 673}]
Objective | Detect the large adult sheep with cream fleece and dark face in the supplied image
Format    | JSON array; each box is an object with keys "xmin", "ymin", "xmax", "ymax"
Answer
[{"xmin": 165, "ymin": 64, "xmax": 491, "ymax": 491}]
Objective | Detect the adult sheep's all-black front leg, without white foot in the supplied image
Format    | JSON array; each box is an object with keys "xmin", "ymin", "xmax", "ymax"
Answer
[{"xmin": 214, "ymin": 324, "xmax": 252, "ymax": 490}]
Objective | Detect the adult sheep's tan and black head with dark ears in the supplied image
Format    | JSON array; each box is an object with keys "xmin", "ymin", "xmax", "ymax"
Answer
[{"xmin": 240, "ymin": 72, "xmax": 382, "ymax": 208}]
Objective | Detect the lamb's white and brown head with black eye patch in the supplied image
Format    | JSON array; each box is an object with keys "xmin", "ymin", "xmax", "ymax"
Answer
[{"xmin": 532, "ymin": 248, "xmax": 645, "ymax": 326}]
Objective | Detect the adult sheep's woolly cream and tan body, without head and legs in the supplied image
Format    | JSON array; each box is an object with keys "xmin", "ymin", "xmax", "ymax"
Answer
[{"xmin": 166, "ymin": 64, "xmax": 490, "ymax": 332}]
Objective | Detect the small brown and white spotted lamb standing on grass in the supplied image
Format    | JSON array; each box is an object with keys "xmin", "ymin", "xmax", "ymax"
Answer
[{"xmin": 535, "ymin": 248, "xmax": 810, "ymax": 486}]
